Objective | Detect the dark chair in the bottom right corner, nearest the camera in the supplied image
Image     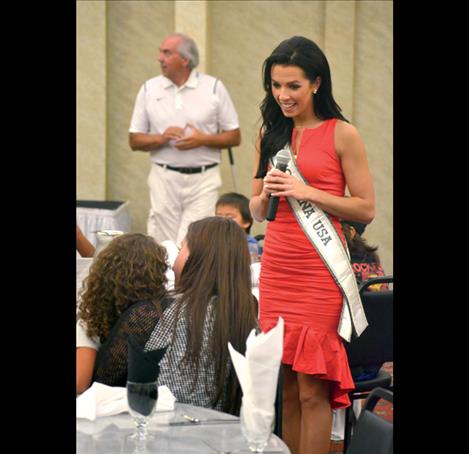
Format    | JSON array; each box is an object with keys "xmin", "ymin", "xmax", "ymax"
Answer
[{"xmin": 344, "ymin": 388, "xmax": 394, "ymax": 454}]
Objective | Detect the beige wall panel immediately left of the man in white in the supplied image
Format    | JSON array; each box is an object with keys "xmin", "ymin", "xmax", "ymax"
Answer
[{"xmin": 106, "ymin": 1, "xmax": 174, "ymax": 238}]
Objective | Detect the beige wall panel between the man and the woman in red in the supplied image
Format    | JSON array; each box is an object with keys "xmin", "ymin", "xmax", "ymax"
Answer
[{"xmin": 208, "ymin": 1, "xmax": 324, "ymax": 234}]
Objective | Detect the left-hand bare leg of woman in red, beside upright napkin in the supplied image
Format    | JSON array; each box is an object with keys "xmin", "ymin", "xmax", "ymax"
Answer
[{"xmin": 282, "ymin": 364, "xmax": 301, "ymax": 454}]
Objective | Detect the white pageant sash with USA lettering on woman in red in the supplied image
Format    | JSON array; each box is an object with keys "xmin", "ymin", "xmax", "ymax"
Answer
[{"xmin": 271, "ymin": 144, "xmax": 368, "ymax": 342}]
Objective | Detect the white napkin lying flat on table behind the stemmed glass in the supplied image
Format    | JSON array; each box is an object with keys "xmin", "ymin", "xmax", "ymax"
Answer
[{"xmin": 77, "ymin": 382, "xmax": 176, "ymax": 421}]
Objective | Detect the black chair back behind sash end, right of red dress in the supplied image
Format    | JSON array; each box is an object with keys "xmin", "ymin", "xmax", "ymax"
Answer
[{"xmin": 344, "ymin": 276, "xmax": 393, "ymax": 367}]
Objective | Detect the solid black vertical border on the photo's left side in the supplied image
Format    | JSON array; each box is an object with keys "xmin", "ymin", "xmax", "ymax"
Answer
[{"xmin": 0, "ymin": 0, "xmax": 76, "ymax": 453}]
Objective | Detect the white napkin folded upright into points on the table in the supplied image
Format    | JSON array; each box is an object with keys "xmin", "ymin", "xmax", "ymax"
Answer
[{"xmin": 228, "ymin": 317, "xmax": 284, "ymax": 436}]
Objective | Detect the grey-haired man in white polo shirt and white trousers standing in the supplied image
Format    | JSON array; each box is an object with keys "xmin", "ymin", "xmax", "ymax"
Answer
[{"xmin": 129, "ymin": 33, "xmax": 241, "ymax": 245}]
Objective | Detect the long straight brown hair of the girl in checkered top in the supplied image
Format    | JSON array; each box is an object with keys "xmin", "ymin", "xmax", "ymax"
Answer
[{"xmin": 176, "ymin": 216, "xmax": 258, "ymax": 414}]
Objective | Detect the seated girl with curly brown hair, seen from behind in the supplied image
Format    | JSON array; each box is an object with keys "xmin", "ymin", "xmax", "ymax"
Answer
[{"xmin": 76, "ymin": 233, "xmax": 169, "ymax": 393}]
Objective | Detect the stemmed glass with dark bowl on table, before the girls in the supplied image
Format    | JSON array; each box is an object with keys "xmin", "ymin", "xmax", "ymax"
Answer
[{"xmin": 127, "ymin": 381, "xmax": 158, "ymax": 452}]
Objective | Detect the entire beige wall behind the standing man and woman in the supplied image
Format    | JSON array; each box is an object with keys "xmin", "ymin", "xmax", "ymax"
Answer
[{"xmin": 77, "ymin": 0, "xmax": 393, "ymax": 273}]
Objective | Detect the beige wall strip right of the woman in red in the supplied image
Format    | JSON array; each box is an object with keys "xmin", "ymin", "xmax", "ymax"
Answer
[{"xmin": 353, "ymin": 1, "xmax": 393, "ymax": 274}]
